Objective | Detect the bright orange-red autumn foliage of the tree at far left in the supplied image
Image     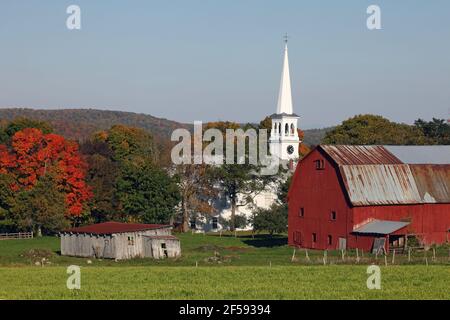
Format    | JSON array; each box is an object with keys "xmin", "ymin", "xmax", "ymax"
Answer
[{"xmin": 0, "ymin": 128, "xmax": 92, "ymax": 217}]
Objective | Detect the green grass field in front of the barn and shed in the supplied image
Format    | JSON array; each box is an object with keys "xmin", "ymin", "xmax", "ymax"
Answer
[{"xmin": 0, "ymin": 234, "xmax": 450, "ymax": 299}]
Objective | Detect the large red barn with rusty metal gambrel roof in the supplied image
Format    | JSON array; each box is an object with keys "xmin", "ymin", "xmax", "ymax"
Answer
[{"xmin": 288, "ymin": 145, "xmax": 450, "ymax": 251}]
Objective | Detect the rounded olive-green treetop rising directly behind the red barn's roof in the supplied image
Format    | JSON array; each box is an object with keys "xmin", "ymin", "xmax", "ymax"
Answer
[{"xmin": 322, "ymin": 115, "xmax": 426, "ymax": 145}]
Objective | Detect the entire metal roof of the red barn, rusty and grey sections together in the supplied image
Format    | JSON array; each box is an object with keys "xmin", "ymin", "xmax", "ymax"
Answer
[{"xmin": 319, "ymin": 145, "xmax": 450, "ymax": 206}]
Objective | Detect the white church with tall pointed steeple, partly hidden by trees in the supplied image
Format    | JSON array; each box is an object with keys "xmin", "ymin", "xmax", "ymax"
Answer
[{"xmin": 191, "ymin": 40, "xmax": 301, "ymax": 232}]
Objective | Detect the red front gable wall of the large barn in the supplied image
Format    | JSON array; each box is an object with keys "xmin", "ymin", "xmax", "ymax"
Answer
[{"xmin": 288, "ymin": 150, "xmax": 352, "ymax": 250}]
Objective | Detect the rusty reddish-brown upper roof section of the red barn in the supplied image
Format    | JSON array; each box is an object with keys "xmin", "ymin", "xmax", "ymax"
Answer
[{"xmin": 320, "ymin": 145, "xmax": 403, "ymax": 165}]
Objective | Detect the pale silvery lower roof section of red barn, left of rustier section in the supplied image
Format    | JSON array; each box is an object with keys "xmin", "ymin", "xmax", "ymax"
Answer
[{"xmin": 340, "ymin": 164, "xmax": 422, "ymax": 206}]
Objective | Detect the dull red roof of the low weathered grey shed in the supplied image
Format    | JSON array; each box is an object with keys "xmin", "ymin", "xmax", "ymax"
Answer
[{"xmin": 63, "ymin": 222, "xmax": 170, "ymax": 235}]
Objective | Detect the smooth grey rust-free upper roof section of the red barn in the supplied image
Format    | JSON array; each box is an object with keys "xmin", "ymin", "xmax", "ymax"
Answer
[{"xmin": 383, "ymin": 146, "xmax": 450, "ymax": 164}]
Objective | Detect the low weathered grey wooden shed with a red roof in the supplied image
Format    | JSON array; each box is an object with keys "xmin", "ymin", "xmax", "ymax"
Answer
[{"xmin": 60, "ymin": 222, "xmax": 181, "ymax": 260}]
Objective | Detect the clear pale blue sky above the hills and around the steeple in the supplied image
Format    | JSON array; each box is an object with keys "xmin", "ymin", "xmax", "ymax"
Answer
[{"xmin": 0, "ymin": 0, "xmax": 450, "ymax": 128}]
